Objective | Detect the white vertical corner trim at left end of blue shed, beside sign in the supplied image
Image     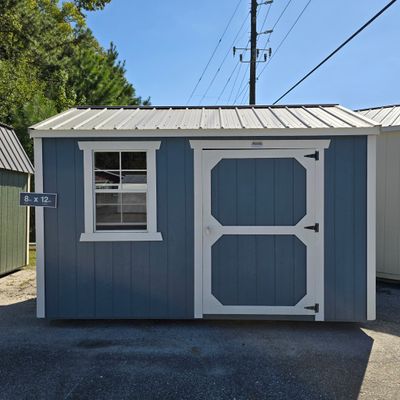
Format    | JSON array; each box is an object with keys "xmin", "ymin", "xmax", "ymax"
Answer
[{"xmin": 33, "ymin": 138, "xmax": 46, "ymax": 318}]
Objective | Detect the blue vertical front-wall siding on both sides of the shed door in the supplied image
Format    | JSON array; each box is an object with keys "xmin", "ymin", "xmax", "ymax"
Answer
[{"xmin": 43, "ymin": 137, "xmax": 367, "ymax": 321}]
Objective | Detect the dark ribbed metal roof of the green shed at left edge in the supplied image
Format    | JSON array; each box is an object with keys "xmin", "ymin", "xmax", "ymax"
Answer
[{"xmin": 0, "ymin": 123, "xmax": 34, "ymax": 174}]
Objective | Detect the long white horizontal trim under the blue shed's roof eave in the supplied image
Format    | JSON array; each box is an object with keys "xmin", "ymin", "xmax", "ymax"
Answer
[{"xmin": 29, "ymin": 126, "xmax": 380, "ymax": 138}]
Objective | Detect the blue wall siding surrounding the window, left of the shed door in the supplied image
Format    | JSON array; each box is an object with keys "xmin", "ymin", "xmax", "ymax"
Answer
[{"xmin": 43, "ymin": 139, "xmax": 194, "ymax": 318}]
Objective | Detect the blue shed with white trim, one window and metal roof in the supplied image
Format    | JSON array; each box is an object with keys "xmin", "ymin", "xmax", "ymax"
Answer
[{"xmin": 30, "ymin": 105, "xmax": 379, "ymax": 321}]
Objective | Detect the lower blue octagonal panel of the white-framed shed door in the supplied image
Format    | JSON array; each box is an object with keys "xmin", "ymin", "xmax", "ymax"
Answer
[{"xmin": 212, "ymin": 235, "xmax": 306, "ymax": 306}]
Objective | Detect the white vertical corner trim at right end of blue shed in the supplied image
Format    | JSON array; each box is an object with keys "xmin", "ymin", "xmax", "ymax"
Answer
[{"xmin": 367, "ymin": 136, "xmax": 376, "ymax": 320}]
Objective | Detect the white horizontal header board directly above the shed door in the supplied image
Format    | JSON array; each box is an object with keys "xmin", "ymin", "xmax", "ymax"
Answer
[{"xmin": 190, "ymin": 139, "xmax": 331, "ymax": 150}]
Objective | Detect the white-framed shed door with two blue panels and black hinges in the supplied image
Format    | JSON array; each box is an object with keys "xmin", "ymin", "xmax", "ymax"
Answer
[{"xmin": 201, "ymin": 148, "xmax": 323, "ymax": 320}]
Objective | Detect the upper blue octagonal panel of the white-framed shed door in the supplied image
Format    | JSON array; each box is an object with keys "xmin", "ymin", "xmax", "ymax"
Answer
[{"xmin": 211, "ymin": 158, "xmax": 306, "ymax": 226}]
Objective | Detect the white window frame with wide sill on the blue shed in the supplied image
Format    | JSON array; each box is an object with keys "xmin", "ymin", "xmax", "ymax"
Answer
[{"xmin": 78, "ymin": 141, "xmax": 162, "ymax": 242}]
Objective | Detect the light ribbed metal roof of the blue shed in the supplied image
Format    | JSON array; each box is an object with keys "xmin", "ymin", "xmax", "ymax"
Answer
[{"xmin": 31, "ymin": 104, "xmax": 378, "ymax": 136}]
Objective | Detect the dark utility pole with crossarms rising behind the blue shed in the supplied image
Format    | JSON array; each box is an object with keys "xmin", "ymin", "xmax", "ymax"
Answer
[{"xmin": 233, "ymin": 0, "xmax": 273, "ymax": 105}]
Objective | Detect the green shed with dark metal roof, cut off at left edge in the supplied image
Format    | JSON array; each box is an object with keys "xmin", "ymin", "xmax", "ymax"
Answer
[{"xmin": 0, "ymin": 123, "xmax": 33, "ymax": 276}]
